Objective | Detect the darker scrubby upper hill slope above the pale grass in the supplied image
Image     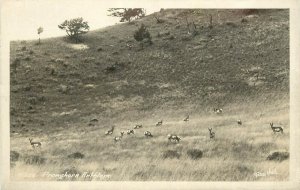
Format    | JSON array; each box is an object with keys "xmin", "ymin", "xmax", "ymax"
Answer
[{"xmin": 11, "ymin": 10, "xmax": 289, "ymax": 131}]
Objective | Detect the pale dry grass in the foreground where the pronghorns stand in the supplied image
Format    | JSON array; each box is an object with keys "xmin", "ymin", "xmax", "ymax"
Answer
[{"xmin": 11, "ymin": 98, "xmax": 289, "ymax": 181}]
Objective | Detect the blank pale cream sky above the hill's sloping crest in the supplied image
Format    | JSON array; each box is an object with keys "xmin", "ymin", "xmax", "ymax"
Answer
[{"xmin": 2, "ymin": 0, "xmax": 159, "ymax": 40}]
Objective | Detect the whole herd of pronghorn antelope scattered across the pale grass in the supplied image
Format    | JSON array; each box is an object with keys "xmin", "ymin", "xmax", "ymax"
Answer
[{"xmin": 29, "ymin": 108, "xmax": 283, "ymax": 148}]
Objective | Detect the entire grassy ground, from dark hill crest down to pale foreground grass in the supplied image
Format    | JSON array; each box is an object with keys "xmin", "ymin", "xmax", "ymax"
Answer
[{"xmin": 10, "ymin": 10, "xmax": 289, "ymax": 180}]
